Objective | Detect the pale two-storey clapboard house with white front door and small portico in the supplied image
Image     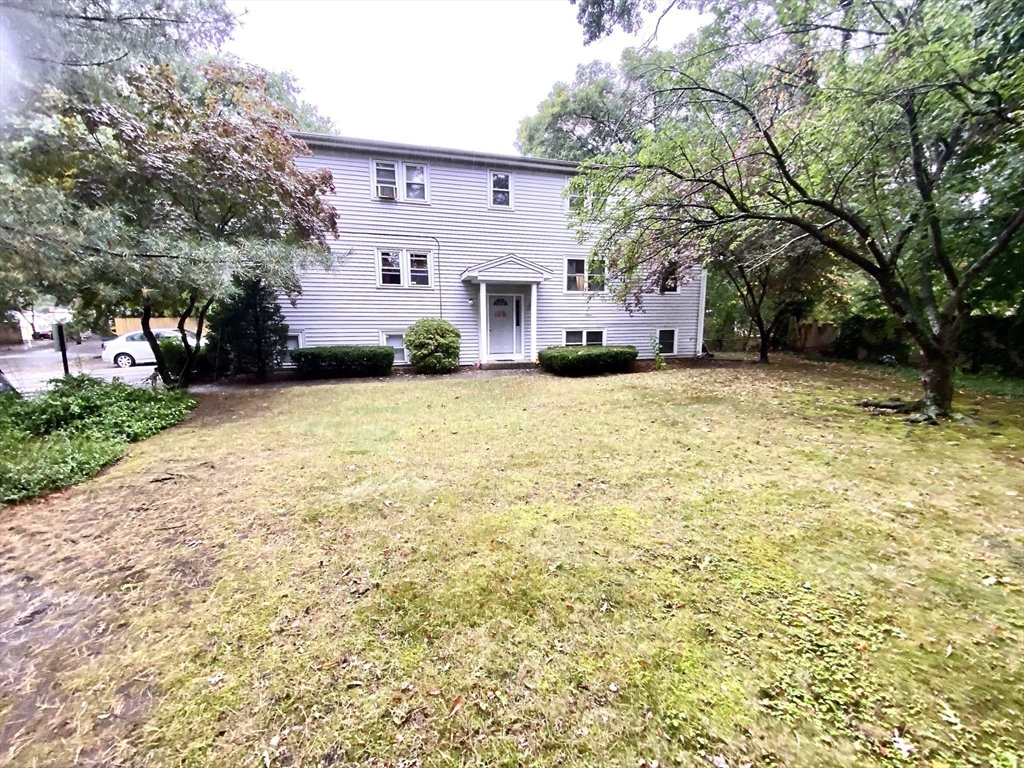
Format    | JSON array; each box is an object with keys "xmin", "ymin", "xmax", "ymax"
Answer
[{"xmin": 284, "ymin": 133, "xmax": 706, "ymax": 365}]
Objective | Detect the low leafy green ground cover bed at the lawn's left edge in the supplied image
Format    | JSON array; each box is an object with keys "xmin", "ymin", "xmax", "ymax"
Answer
[{"xmin": 0, "ymin": 376, "xmax": 196, "ymax": 503}]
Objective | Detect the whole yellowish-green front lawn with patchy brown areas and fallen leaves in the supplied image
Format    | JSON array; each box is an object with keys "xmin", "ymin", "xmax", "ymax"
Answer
[{"xmin": 0, "ymin": 359, "xmax": 1024, "ymax": 768}]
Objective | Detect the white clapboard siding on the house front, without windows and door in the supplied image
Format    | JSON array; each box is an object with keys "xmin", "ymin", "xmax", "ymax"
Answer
[{"xmin": 282, "ymin": 134, "xmax": 703, "ymax": 365}]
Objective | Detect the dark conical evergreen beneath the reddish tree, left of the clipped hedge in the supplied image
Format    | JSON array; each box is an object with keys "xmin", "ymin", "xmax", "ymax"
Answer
[{"xmin": 210, "ymin": 278, "xmax": 288, "ymax": 381}]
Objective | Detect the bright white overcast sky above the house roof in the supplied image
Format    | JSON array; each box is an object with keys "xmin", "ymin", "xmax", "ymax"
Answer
[{"xmin": 227, "ymin": 0, "xmax": 695, "ymax": 154}]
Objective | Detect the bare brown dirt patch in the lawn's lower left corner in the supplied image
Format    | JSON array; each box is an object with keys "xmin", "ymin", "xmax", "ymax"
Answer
[{"xmin": 0, "ymin": 417, "xmax": 228, "ymax": 765}]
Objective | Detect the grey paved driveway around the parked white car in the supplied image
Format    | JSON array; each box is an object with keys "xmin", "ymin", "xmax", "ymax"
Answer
[{"xmin": 0, "ymin": 339, "xmax": 154, "ymax": 394}]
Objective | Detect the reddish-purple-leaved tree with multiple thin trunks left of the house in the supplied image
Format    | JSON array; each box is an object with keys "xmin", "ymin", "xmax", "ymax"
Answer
[{"xmin": 0, "ymin": 60, "xmax": 336, "ymax": 385}]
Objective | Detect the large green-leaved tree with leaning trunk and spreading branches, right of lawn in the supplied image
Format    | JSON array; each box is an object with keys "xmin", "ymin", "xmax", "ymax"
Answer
[{"xmin": 573, "ymin": 0, "xmax": 1024, "ymax": 418}]
